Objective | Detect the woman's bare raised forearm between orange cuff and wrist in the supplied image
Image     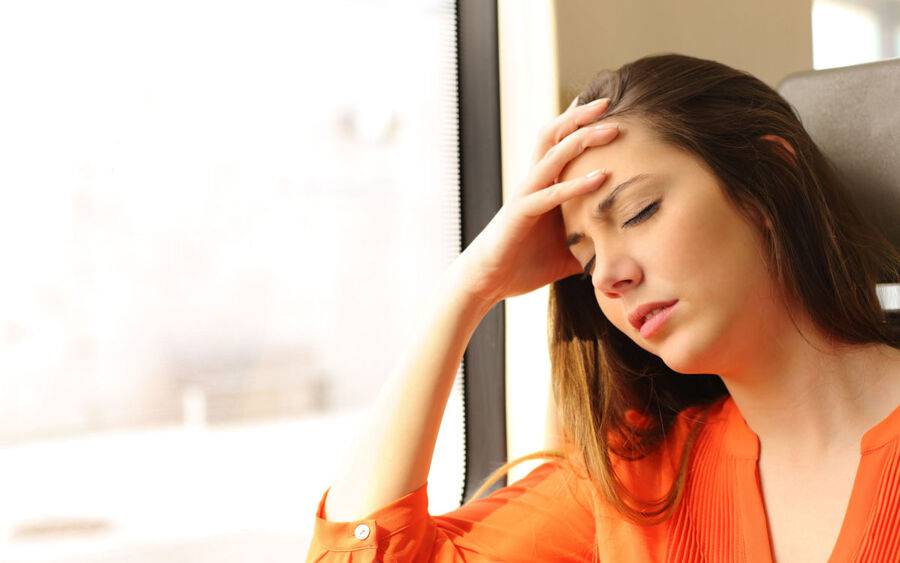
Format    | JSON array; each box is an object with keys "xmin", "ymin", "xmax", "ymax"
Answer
[{"xmin": 325, "ymin": 261, "xmax": 490, "ymax": 521}]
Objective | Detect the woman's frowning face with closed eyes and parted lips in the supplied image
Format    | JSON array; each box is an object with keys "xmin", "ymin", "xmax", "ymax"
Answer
[{"xmin": 559, "ymin": 117, "xmax": 786, "ymax": 373}]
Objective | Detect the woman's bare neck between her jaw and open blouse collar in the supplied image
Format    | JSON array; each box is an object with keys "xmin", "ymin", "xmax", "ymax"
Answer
[{"xmin": 720, "ymin": 312, "xmax": 900, "ymax": 465}]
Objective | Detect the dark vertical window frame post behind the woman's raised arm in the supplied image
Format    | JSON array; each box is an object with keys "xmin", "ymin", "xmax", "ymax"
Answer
[{"xmin": 456, "ymin": 0, "xmax": 507, "ymax": 503}]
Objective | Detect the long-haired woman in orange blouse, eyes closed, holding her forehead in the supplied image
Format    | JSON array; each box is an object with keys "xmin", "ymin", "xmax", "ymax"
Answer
[{"xmin": 309, "ymin": 55, "xmax": 900, "ymax": 562}]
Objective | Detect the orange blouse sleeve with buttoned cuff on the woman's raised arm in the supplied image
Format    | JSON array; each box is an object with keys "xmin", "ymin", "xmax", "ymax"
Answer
[{"xmin": 306, "ymin": 461, "xmax": 594, "ymax": 563}]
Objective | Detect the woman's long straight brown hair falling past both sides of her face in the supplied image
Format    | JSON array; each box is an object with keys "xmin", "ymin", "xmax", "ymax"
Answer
[{"xmin": 472, "ymin": 54, "xmax": 900, "ymax": 556}]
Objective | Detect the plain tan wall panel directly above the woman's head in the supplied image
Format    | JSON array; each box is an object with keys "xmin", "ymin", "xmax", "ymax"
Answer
[{"xmin": 553, "ymin": 0, "xmax": 812, "ymax": 110}]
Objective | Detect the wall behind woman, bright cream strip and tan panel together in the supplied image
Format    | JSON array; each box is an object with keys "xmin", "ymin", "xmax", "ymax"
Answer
[{"xmin": 498, "ymin": 0, "xmax": 812, "ymax": 482}]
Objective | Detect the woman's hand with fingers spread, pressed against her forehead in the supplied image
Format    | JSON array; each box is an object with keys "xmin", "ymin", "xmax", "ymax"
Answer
[{"xmin": 457, "ymin": 98, "xmax": 619, "ymax": 304}]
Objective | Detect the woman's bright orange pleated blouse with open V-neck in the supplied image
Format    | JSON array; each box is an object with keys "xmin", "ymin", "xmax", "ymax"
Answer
[{"xmin": 307, "ymin": 396, "xmax": 900, "ymax": 563}]
